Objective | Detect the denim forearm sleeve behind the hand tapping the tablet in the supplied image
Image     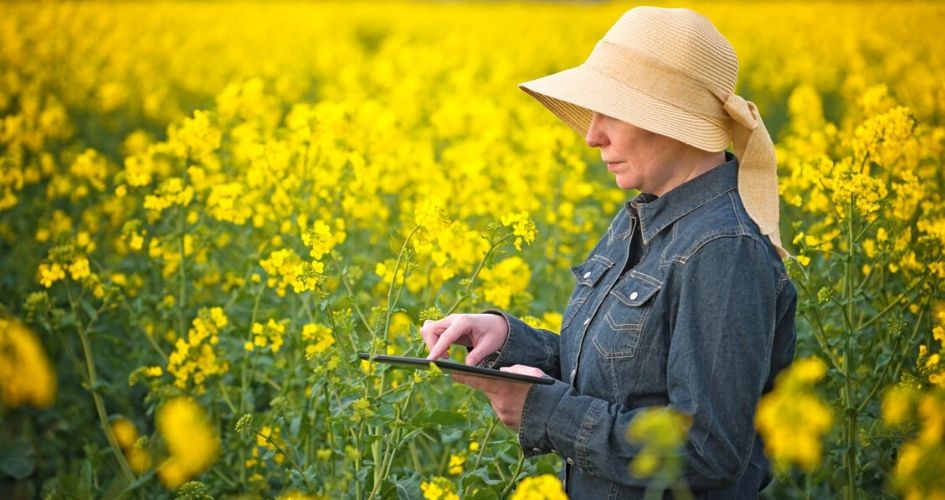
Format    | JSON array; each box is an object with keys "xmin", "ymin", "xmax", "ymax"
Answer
[{"xmin": 479, "ymin": 309, "xmax": 561, "ymax": 379}]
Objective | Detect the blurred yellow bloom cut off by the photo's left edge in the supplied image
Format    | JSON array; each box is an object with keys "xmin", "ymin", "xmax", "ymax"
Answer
[{"xmin": 0, "ymin": 317, "xmax": 56, "ymax": 408}]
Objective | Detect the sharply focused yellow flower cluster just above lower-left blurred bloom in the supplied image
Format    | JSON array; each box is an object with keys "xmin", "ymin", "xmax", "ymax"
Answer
[{"xmin": 167, "ymin": 307, "xmax": 228, "ymax": 392}]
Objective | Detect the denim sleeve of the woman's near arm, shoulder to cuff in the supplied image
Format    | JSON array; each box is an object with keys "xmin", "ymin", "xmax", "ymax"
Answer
[{"xmin": 519, "ymin": 237, "xmax": 783, "ymax": 489}]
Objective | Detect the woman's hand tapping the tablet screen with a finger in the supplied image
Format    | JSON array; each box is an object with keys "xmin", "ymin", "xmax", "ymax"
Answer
[{"xmin": 420, "ymin": 313, "xmax": 509, "ymax": 365}]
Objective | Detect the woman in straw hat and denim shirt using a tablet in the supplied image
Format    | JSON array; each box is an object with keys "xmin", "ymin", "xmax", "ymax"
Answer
[{"xmin": 421, "ymin": 7, "xmax": 796, "ymax": 499}]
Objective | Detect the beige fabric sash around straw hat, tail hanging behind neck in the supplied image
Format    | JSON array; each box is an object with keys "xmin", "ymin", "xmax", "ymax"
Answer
[{"xmin": 583, "ymin": 40, "xmax": 788, "ymax": 258}]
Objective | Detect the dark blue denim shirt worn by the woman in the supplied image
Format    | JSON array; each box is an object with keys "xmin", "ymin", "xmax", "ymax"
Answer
[{"xmin": 482, "ymin": 153, "xmax": 797, "ymax": 499}]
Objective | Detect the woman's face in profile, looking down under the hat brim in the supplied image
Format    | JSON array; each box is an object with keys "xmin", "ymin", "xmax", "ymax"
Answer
[{"xmin": 584, "ymin": 113, "xmax": 684, "ymax": 196}]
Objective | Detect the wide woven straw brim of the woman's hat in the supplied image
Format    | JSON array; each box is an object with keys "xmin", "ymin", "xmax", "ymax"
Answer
[{"xmin": 519, "ymin": 66, "xmax": 732, "ymax": 151}]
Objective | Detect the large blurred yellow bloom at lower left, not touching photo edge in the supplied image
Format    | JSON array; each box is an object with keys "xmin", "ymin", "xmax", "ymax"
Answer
[{"xmin": 155, "ymin": 397, "xmax": 220, "ymax": 490}]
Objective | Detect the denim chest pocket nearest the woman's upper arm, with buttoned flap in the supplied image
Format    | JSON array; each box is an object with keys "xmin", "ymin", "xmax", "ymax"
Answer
[{"xmin": 594, "ymin": 273, "xmax": 660, "ymax": 359}]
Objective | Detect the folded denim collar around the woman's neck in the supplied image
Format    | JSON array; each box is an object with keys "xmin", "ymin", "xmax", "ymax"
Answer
[{"xmin": 624, "ymin": 151, "xmax": 738, "ymax": 244}]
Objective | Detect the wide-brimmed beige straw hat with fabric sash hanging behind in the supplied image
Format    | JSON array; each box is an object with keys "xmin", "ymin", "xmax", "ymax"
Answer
[{"xmin": 519, "ymin": 7, "xmax": 788, "ymax": 257}]
